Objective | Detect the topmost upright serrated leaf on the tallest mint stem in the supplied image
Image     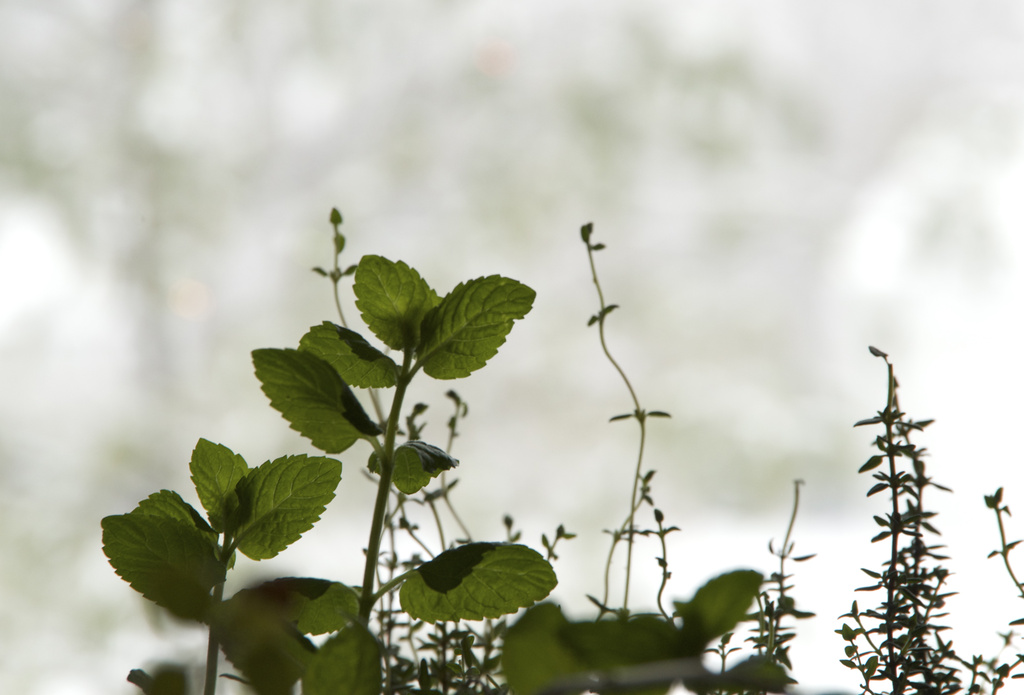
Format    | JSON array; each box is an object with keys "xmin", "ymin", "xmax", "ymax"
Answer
[{"xmin": 352, "ymin": 256, "xmax": 439, "ymax": 350}]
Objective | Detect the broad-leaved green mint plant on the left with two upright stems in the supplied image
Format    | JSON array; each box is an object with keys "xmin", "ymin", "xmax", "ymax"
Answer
[{"xmin": 102, "ymin": 211, "xmax": 556, "ymax": 695}]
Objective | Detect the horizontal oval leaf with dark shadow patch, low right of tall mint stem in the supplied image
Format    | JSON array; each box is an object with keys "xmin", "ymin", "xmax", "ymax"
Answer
[{"xmin": 399, "ymin": 542, "xmax": 558, "ymax": 622}]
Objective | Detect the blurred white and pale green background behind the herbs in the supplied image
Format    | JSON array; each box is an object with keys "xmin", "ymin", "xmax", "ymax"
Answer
[{"xmin": 0, "ymin": 0, "xmax": 1024, "ymax": 695}]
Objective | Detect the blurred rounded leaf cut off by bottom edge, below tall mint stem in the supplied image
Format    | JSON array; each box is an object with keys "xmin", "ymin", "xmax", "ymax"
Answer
[{"xmin": 302, "ymin": 622, "xmax": 384, "ymax": 695}]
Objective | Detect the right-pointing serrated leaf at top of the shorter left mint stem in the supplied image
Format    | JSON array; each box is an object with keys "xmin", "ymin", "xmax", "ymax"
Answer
[{"xmin": 236, "ymin": 453, "xmax": 341, "ymax": 560}]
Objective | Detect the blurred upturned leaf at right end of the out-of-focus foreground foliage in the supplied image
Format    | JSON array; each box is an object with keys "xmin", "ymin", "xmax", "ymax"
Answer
[{"xmin": 674, "ymin": 569, "xmax": 764, "ymax": 656}]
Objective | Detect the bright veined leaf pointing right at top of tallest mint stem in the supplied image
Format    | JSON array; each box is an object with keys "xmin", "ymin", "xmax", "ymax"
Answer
[{"xmin": 418, "ymin": 275, "xmax": 537, "ymax": 379}]
